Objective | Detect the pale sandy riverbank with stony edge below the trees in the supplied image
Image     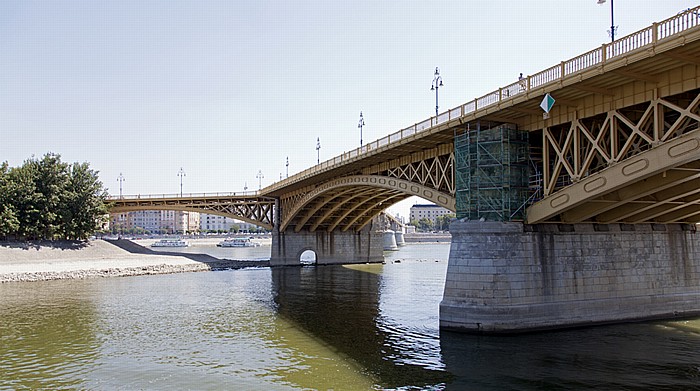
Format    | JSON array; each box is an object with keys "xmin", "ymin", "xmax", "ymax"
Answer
[{"xmin": 0, "ymin": 240, "xmax": 269, "ymax": 283}]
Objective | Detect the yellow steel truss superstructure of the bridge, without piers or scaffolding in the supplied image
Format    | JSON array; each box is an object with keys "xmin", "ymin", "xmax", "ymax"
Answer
[{"xmin": 111, "ymin": 7, "xmax": 700, "ymax": 232}]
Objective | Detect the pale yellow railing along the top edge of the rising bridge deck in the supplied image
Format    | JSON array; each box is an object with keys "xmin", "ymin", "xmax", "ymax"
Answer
[{"xmin": 269, "ymin": 6, "xmax": 700, "ymax": 194}]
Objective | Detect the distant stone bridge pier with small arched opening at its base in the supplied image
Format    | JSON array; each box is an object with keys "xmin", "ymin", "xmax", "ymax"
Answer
[{"xmin": 270, "ymin": 224, "xmax": 384, "ymax": 266}]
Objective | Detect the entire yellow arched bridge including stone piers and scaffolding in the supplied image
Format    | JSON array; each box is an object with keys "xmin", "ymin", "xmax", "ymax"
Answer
[{"xmin": 112, "ymin": 7, "xmax": 700, "ymax": 333}]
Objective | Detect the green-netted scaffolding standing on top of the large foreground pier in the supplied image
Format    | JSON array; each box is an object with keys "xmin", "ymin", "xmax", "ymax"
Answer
[{"xmin": 454, "ymin": 124, "xmax": 531, "ymax": 221}]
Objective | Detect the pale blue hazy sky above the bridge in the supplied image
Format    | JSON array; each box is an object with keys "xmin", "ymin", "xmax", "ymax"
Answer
[{"xmin": 0, "ymin": 0, "xmax": 700, "ymax": 220}]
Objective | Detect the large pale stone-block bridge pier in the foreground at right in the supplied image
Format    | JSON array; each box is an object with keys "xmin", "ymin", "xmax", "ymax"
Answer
[{"xmin": 440, "ymin": 221, "xmax": 700, "ymax": 333}]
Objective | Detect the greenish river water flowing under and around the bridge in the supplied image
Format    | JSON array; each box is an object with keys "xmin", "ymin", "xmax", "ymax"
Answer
[{"xmin": 0, "ymin": 244, "xmax": 700, "ymax": 390}]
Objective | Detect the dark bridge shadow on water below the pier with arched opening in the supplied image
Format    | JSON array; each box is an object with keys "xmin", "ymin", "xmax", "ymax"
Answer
[{"xmin": 272, "ymin": 265, "xmax": 451, "ymax": 389}]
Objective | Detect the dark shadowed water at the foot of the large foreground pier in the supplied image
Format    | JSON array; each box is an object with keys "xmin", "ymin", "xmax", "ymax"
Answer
[{"xmin": 440, "ymin": 320, "xmax": 700, "ymax": 390}]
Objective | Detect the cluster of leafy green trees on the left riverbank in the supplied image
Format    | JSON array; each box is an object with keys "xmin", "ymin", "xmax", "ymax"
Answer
[{"xmin": 0, "ymin": 153, "xmax": 107, "ymax": 240}]
